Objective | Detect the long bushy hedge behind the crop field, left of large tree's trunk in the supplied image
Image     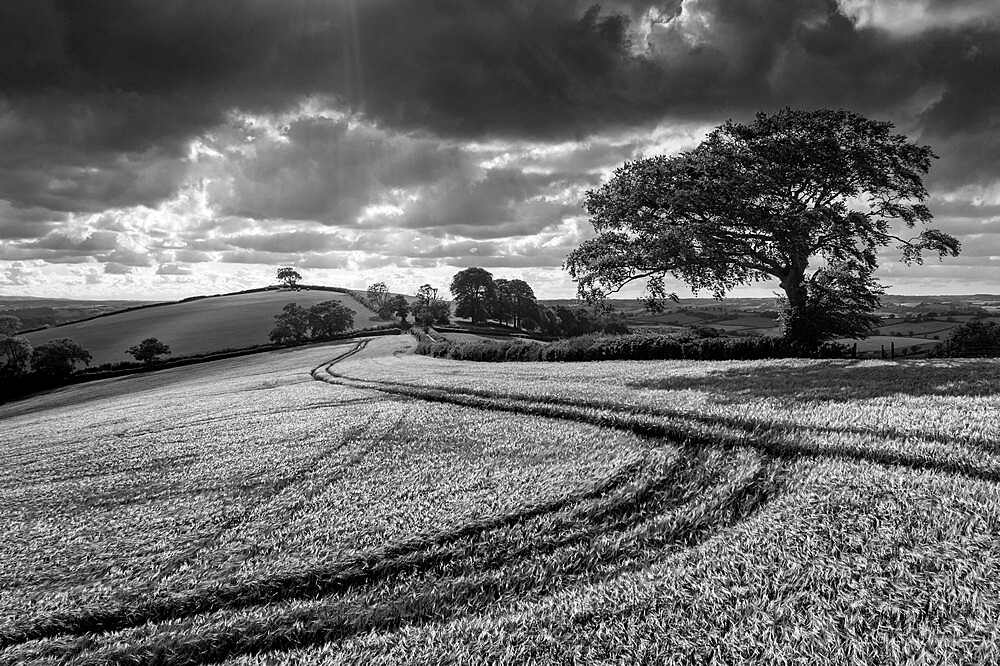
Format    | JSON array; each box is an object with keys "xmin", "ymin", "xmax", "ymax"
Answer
[{"xmin": 415, "ymin": 332, "xmax": 820, "ymax": 362}]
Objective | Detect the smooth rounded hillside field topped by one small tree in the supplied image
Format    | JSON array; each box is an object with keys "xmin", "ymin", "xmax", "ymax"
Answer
[{"xmin": 25, "ymin": 290, "xmax": 375, "ymax": 365}]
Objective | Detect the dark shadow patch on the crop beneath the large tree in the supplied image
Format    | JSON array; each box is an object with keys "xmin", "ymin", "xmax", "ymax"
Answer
[{"xmin": 626, "ymin": 359, "xmax": 1000, "ymax": 404}]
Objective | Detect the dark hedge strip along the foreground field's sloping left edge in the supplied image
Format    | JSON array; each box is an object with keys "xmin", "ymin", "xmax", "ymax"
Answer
[{"xmin": 0, "ymin": 324, "xmax": 403, "ymax": 404}]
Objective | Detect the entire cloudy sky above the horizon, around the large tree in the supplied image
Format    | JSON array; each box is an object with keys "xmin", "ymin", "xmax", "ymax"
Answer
[{"xmin": 0, "ymin": 0, "xmax": 1000, "ymax": 300}]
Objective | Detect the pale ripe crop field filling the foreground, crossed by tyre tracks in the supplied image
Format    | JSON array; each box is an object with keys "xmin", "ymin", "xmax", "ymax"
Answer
[{"xmin": 0, "ymin": 336, "xmax": 1000, "ymax": 666}]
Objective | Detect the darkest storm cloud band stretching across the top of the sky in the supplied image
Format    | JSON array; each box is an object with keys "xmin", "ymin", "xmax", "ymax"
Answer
[{"xmin": 0, "ymin": 0, "xmax": 997, "ymax": 145}]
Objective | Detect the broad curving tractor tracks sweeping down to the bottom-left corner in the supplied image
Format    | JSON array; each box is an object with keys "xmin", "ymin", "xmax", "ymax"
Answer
[{"xmin": 0, "ymin": 448, "xmax": 784, "ymax": 664}]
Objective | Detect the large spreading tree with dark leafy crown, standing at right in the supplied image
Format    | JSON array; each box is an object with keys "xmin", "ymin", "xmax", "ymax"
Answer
[{"xmin": 565, "ymin": 109, "xmax": 960, "ymax": 351}]
